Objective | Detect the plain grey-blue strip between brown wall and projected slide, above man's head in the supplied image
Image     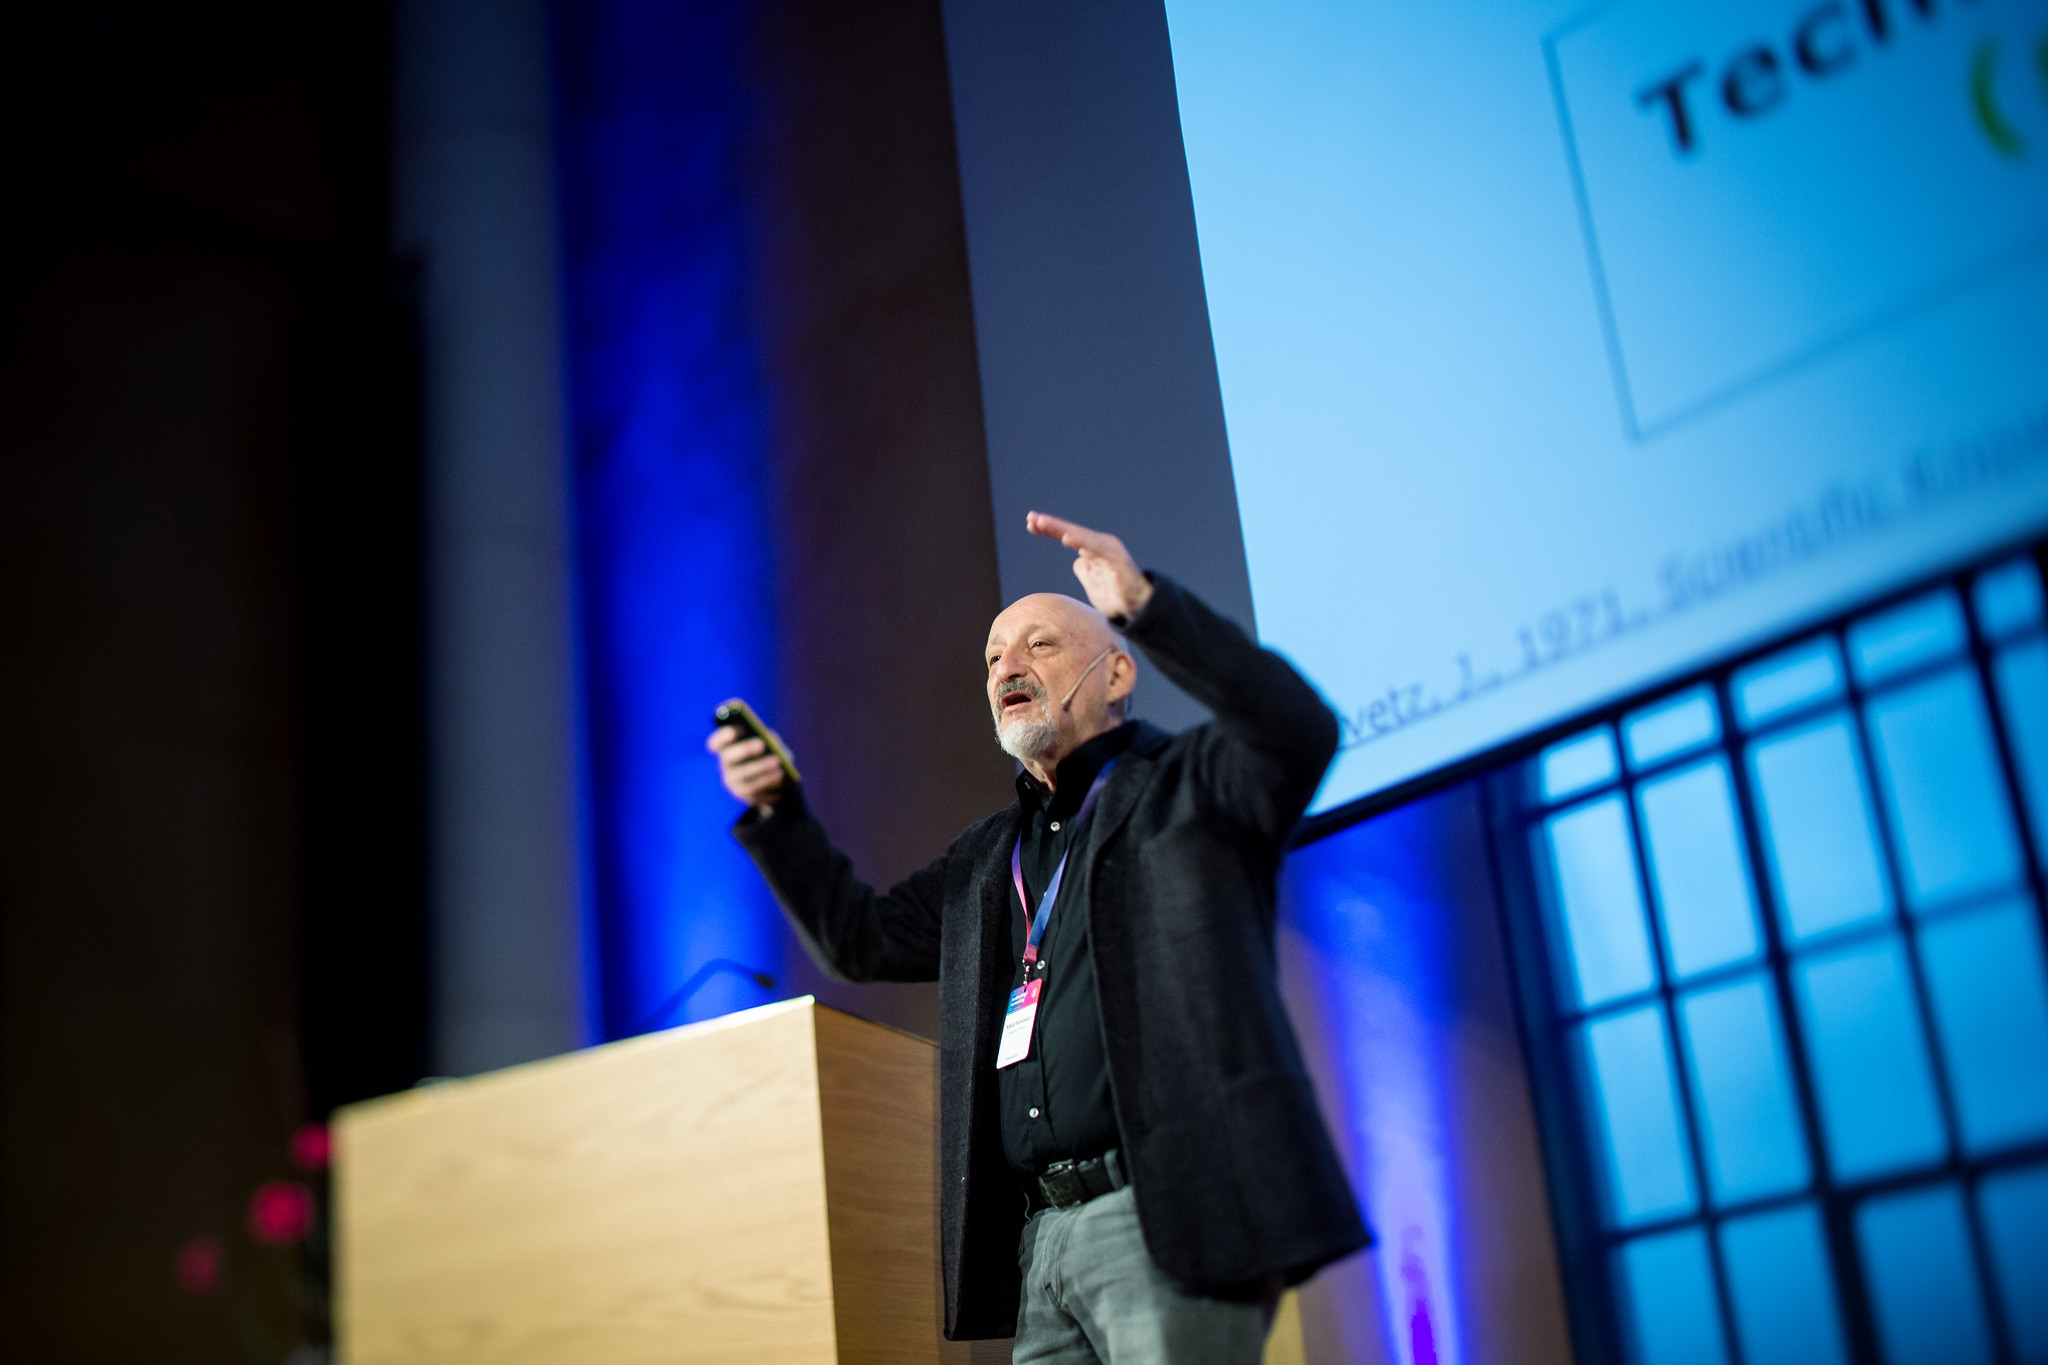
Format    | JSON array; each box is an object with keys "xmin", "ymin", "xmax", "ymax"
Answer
[{"xmin": 944, "ymin": 0, "xmax": 1255, "ymax": 729}]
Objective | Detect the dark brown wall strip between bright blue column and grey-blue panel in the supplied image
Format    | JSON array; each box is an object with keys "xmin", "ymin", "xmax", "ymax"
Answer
[{"xmin": 750, "ymin": 0, "xmax": 1016, "ymax": 1038}]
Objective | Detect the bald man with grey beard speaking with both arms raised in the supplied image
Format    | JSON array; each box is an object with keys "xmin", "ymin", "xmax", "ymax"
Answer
[{"xmin": 709, "ymin": 512, "xmax": 1370, "ymax": 1365}]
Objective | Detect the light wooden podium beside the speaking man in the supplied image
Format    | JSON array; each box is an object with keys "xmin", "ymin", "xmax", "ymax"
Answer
[{"xmin": 336, "ymin": 997, "xmax": 991, "ymax": 1365}]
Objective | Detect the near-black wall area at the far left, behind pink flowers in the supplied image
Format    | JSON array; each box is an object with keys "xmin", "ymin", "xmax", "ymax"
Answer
[{"xmin": 0, "ymin": 2, "xmax": 424, "ymax": 1365}]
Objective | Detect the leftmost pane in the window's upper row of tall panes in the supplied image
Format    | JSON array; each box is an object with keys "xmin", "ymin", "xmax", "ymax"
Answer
[{"xmin": 1544, "ymin": 796, "xmax": 1657, "ymax": 1009}]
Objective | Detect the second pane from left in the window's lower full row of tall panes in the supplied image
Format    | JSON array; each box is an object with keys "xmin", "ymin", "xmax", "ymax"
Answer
[{"xmin": 1677, "ymin": 976, "xmax": 1808, "ymax": 1203}]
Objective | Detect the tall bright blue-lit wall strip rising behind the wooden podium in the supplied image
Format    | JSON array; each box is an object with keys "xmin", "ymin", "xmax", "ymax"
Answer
[{"xmin": 553, "ymin": 0, "xmax": 782, "ymax": 1038}]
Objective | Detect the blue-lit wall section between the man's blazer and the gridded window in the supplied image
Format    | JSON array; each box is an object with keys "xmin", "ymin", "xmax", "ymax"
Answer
[{"xmin": 1278, "ymin": 784, "xmax": 1565, "ymax": 1365}]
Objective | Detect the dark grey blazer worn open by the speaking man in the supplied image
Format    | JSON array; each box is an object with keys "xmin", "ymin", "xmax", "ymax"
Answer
[{"xmin": 735, "ymin": 577, "xmax": 1372, "ymax": 1340}]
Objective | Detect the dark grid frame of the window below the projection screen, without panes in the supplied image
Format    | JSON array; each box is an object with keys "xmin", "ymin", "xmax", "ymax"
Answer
[{"xmin": 1483, "ymin": 542, "xmax": 2048, "ymax": 1365}]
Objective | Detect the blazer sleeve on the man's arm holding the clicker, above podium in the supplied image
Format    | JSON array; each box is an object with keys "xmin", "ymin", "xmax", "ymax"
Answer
[{"xmin": 733, "ymin": 786, "xmax": 952, "ymax": 980}]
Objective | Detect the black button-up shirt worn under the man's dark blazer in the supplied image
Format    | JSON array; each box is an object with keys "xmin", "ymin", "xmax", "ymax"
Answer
[{"xmin": 995, "ymin": 722, "xmax": 1137, "ymax": 1175}]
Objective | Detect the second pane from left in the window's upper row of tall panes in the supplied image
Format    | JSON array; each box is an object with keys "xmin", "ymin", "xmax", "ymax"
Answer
[{"xmin": 1636, "ymin": 757, "xmax": 1763, "ymax": 978}]
